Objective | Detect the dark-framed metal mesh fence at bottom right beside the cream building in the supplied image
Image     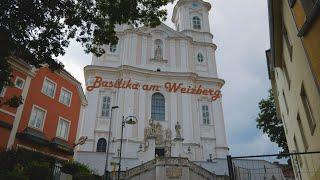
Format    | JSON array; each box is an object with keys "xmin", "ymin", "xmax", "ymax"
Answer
[{"xmin": 227, "ymin": 151, "xmax": 320, "ymax": 180}]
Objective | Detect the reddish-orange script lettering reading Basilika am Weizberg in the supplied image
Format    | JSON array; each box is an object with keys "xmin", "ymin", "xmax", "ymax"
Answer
[{"xmin": 87, "ymin": 76, "xmax": 222, "ymax": 101}]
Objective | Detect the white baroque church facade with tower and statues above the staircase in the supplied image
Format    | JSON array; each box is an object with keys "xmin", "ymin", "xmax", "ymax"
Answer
[{"xmin": 75, "ymin": 0, "xmax": 229, "ymax": 174}]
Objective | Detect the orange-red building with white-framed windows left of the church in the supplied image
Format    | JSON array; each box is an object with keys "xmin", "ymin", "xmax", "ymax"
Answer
[{"xmin": 0, "ymin": 60, "xmax": 87, "ymax": 160}]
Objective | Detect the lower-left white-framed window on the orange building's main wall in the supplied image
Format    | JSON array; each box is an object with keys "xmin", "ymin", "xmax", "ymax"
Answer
[{"xmin": 29, "ymin": 106, "xmax": 46, "ymax": 130}]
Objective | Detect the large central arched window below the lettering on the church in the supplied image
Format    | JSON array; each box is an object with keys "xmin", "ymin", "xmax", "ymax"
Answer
[{"xmin": 151, "ymin": 93, "xmax": 165, "ymax": 121}]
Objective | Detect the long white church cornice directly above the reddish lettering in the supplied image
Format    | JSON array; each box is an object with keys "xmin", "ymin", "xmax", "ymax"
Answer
[{"xmin": 84, "ymin": 65, "xmax": 225, "ymax": 87}]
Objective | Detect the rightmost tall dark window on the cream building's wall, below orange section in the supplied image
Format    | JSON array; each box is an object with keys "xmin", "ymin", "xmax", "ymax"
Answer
[{"xmin": 300, "ymin": 84, "xmax": 316, "ymax": 135}]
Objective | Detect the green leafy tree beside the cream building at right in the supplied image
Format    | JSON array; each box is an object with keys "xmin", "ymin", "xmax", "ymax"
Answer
[{"xmin": 256, "ymin": 89, "xmax": 289, "ymax": 157}]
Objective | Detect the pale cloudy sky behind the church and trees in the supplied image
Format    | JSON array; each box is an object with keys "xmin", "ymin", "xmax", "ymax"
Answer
[{"xmin": 59, "ymin": 0, "xmax": 279, "ymax": 156}]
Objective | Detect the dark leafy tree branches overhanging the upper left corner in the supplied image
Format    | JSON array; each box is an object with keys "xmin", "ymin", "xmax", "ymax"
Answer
[{"xmin": 0, "ymin": 0, "xmax": 173, "ymax": 105}]
